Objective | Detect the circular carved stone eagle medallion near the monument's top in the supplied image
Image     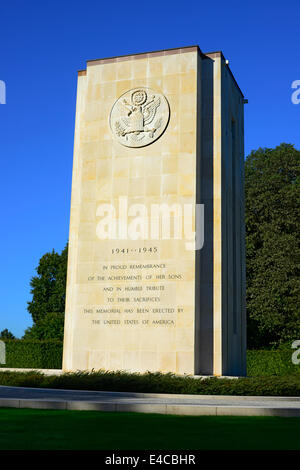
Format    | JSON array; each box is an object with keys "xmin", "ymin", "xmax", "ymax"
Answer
[{"xmin": 109, "ymin": 87, "xmax": 170, "ymax": 147}]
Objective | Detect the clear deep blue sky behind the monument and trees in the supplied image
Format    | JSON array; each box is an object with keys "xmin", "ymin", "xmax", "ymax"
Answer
[{"xmin": 0, "ymin": 0, "xmax": 300, "ymax": 336}]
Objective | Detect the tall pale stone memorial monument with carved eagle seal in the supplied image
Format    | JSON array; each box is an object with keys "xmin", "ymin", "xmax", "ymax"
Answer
[{"xmin": 63, "ymin": 46, "xmax": 246, "ymax": 376}]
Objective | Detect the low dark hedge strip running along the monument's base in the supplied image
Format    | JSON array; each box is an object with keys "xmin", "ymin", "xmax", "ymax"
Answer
[{"xmin": 0, "ymin": 370, "xmax": 300, "ymax": 397}]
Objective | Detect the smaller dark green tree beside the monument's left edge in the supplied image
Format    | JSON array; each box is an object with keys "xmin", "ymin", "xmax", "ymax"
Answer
[{"xmin": 27, "ymin": 245, "xmax": 68, "ymax": 323}]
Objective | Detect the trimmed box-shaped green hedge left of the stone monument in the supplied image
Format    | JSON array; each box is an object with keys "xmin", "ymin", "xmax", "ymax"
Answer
[{"xmin": 1, "ymin": 339, "xmax": 63, "ymax": 369}]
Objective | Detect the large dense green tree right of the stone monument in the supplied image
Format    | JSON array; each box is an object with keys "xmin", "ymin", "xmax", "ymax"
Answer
[{"xmin": 245, "ymin": 144, "xmax": 300, "ymax": 347}]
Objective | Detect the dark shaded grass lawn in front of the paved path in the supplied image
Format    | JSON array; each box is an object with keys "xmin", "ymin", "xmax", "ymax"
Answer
[{"xmin": 0, "ymin": 408, "xmax": 300, "ymax": 450}]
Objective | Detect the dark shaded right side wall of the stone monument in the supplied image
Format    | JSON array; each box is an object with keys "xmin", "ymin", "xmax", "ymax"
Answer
[{"xmin": 221, "ymin": 58, "xmax": 246, "ymax": 375}]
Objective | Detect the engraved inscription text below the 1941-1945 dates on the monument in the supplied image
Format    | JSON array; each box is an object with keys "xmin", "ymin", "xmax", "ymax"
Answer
[{"xmin": 82, "ymin": 262, "xmax": 185, "ymax": 327}]
